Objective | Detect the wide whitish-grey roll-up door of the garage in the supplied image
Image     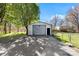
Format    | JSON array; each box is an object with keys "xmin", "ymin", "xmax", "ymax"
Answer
[{"xmin": 33, "ymin": 25, "xmax": 46, "ymax": 35}]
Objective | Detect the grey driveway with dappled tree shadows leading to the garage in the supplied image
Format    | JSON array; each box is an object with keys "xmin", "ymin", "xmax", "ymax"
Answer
[{"xmin": 0, "ymin": 36, "xmax": 79, "ymax": 56}]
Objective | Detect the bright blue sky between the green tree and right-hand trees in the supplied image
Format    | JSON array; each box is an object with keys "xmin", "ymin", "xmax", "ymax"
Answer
[{"xmin": 39, "ymin": 3, "xmax": 78, "ymax": 22}]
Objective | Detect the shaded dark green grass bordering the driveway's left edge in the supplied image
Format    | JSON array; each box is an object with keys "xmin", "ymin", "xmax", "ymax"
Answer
[{"xmin": 0, "ymin": 33, "xmax": 26, "ymax": 43}]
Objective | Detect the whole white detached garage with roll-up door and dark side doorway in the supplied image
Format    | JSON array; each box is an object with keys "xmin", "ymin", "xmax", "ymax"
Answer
[{"xmin": 28, "ymin": 22, "xmax": 52, "ymax": 35}]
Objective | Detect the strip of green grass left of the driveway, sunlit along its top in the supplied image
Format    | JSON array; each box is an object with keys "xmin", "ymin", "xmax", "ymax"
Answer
[{"xmin": 0, "ymin": 32, "xmax": 26, "ymax": 43}]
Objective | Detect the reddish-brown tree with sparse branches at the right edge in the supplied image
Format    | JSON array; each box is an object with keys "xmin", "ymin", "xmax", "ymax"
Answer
[{"xmin": 67, "ymin": 6, "xmax": 79, "ymax": 32}]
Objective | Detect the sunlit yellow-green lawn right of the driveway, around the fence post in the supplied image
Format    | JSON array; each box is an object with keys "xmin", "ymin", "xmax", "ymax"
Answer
[{"xmin": 56, "ymin": 32, "xmax": 79, "ymax": 48}]
